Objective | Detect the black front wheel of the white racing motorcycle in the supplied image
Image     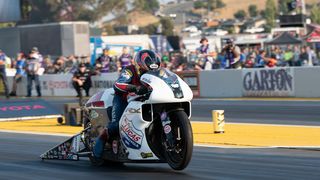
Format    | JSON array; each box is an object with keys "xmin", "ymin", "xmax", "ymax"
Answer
[{"xmin": 164, "ymin": 111, "xmax": 193, "ymax": 170}]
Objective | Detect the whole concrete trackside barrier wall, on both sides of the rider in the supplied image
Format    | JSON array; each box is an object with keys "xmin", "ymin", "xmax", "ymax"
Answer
[{"xmin": 8, "ymin": 67, "xmax": 320, "ymax": 98}]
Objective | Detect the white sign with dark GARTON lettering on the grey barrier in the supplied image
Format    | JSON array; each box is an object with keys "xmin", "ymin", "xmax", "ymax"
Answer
[{"xmin": 242, "ymin": 68, "xmax": 294, "ymax": 97}]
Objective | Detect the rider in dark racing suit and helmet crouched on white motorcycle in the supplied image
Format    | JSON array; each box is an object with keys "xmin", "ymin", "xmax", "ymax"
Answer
[{"xmin": 93, "ymin": 50, "xmax": 161, "ymax": 161}]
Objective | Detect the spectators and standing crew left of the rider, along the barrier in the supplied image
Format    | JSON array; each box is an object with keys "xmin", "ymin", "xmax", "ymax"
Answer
[{"xmin": 0, "ymin": 47, "xmax": 133, "ymax": 98}]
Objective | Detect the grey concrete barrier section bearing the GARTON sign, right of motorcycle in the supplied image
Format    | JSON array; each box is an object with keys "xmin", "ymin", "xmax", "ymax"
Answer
[{"xmin": 200, "ymin": 67, "xmax": 320, "ymax": 98}]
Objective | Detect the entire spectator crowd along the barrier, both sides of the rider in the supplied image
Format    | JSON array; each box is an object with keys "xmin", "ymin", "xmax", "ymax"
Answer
[{"xmin": 0, "ymin": 37, "xmax": 319, "ymax": 98}]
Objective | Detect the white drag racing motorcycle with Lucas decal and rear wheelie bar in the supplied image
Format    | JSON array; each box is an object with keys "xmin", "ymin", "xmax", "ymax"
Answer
[{"xmin": 40, "ymin": 68, "xmax": 193, "ymax": 170}]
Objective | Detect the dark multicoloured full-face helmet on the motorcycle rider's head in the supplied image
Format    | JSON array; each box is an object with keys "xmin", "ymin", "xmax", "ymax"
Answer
[{"xmin": 134, "ymin": 50, "xmax": 161, "ymax": 73}]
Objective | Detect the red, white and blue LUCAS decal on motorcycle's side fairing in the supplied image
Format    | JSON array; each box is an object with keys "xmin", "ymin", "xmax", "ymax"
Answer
[{"xmin": 120, "ymin": 117, "xmax": 143, "ymax": 149}]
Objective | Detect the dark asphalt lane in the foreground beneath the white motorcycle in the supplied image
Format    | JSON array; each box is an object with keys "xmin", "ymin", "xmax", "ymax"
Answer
[{"xmin": 0, "ymin": 132, "xmax": 320, "ymax": 180}]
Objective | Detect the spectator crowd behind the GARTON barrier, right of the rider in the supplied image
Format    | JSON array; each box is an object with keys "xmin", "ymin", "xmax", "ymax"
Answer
[{"xmin": 176, "ymin": 38, "xmax": 320, "ymax": 71}]
